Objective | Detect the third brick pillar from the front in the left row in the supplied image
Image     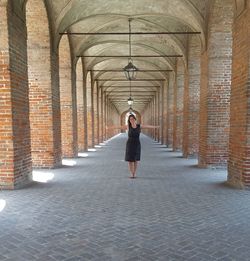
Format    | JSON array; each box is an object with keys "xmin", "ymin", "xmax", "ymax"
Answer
[{"xmin": 59, "ymin": 36, "xmax": 78, "ymax": 157}]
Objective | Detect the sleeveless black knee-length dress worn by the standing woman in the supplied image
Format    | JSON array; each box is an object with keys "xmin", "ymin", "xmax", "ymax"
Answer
[{"xmin": 125, "ymin": 124, "xmax": 141, "ymax": 161}]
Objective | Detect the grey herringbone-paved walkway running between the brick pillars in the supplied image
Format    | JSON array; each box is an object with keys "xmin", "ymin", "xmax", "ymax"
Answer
[{"xmin": 0, "ymin": 134, "xmax": 250, "ymax": 261}]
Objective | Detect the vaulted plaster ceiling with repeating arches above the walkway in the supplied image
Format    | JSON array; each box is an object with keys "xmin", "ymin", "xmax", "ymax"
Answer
[{"xmin": 17, "ymin": 0, "xmax": 211, "ymax": 112}]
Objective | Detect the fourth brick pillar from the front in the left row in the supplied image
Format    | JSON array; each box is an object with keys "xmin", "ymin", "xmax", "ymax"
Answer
[{"xmin": 76, "ymin": 59, "xmax": 85, "ymax": 151}]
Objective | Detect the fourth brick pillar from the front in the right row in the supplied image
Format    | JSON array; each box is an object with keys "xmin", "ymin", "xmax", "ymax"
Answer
[{"xmin": 173, "ymin": 59, "xmax": 185, "ymax": 151}]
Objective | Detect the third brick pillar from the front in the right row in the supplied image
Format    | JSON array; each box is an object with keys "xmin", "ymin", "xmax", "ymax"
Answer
[{"xmin": 183, "ymin": 37, "xmax": 201, "ymax": 158}]
